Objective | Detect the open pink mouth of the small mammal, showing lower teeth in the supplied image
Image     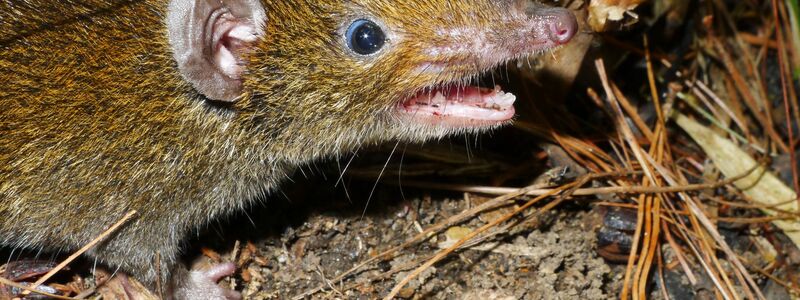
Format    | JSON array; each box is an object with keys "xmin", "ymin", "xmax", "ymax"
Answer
[{"xmin": 397, "ymin": 84, "xmax": 516, "ymax": 127}]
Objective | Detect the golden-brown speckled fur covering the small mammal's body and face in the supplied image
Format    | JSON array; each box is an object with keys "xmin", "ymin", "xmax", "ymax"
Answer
[{"xmin": 0, "ymin": 0, "xmax": 576, "ymax": 292}]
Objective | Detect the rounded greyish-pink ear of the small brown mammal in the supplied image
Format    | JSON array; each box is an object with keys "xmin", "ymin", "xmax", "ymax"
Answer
[{"xmin": 166, "ymin": 0, "xmax": 267, "ymax": 102}]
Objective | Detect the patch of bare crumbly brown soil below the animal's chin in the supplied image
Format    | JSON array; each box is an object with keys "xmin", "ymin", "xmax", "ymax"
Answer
[{"xmin": 231, "ymin": 183, "xmax": 621, "ymax": 299}]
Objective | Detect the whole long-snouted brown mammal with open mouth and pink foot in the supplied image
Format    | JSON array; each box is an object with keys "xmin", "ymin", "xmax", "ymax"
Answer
[{"xmin": 0, "ymin": 0, "xmax": 577, "ymax": 299}]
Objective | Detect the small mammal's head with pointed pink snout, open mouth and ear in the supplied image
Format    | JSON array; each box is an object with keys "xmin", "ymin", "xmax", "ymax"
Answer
[{"xmin": 168, "ymin": 0, "xmax": 577, "ymax": 162}]
